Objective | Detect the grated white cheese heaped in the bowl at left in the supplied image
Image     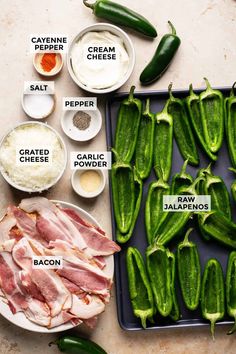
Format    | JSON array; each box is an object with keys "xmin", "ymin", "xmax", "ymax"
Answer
[{"xmin": 0, "ymin": 124, "xmax": 65, "ymax": 191}]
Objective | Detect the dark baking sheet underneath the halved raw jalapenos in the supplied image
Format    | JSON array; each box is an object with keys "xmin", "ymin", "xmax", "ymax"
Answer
[{"xmin": 106, "ymin": 88, "xmax": 236, "ymax": 330}]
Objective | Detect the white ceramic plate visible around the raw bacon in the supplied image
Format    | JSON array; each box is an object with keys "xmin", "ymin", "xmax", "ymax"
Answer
[{"xmin": 0, "ymin": 200, "xmax": 114, "ymax": 333}]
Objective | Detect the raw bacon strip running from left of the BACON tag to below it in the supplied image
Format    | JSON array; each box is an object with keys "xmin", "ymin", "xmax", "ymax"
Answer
[{"xmin": 12, "ymin": 238, "xmax": 71, "ymax": 317}]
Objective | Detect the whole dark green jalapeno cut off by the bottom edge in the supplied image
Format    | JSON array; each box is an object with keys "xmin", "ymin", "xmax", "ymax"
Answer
[{"xmin": 49, "ymin": 335, "xmax": 107, "ymax": 354}]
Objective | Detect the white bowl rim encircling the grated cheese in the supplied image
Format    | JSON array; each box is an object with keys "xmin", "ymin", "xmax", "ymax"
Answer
[{"xmin": 0, "ymin": 121, "xmax": 67, "ymax": 193}]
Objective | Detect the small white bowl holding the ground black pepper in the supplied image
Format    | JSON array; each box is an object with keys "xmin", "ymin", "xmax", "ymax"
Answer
[{"xmin": 61, "ymin": 109, "xmax": 102, "ymax": 141}]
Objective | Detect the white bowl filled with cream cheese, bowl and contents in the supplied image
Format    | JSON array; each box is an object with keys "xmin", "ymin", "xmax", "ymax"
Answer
[{"xmin": 67, "ymin": 23, "xmax": 135, "ymax": 94}]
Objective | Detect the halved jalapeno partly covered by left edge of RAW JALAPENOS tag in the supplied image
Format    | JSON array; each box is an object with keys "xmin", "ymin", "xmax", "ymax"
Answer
[{"xmin": 145, "ymin": 178, "xmax": 170, "ymax": 244}]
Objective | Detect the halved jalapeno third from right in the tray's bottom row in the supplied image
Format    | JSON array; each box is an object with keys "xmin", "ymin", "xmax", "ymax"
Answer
[{"xmin": 177, "ymin": 229, "xmax": 201, "ymax": 310}]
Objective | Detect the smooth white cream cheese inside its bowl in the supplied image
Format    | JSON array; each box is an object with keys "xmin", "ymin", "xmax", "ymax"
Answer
[{"xmin": 71, "ymin": 31, "xmax": 130, "ymax": 89}]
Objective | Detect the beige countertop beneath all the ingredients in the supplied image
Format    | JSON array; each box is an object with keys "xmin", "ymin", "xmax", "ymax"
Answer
[{"xmin": 0, "ymin": 0, "xmax": 236, "ymax": 354}]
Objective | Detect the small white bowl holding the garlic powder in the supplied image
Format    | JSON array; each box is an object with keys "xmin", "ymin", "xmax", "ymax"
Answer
[{"xmin": 71, "ymin": 169, "xmax": 106, "ymax": 198}]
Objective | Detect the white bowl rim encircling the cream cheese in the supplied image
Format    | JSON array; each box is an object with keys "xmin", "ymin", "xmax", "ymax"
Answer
[{"xmin": 67, "ymin": 23, "xmax": 135, "ymax": 94}]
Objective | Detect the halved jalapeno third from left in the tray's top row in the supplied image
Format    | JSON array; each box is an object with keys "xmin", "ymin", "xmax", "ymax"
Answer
[{"xmin": 153, "ymin": 100, "xmax": 173, "ymax": 181}]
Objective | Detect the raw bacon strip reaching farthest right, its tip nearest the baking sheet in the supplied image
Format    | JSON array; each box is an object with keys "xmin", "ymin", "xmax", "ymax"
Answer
[{"xmin": 60, "ymin": 211, "xmax": 120, "ymax": 256}]
